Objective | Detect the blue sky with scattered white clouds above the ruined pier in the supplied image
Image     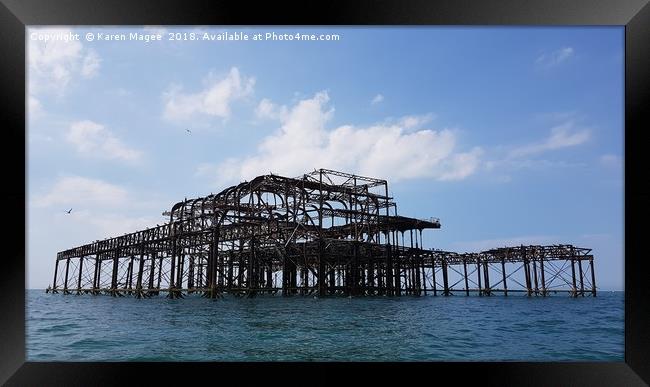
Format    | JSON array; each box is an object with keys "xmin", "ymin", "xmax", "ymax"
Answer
[{"xmin": 26, "ymin": 27, "xmax": 624, "ymax": 290}]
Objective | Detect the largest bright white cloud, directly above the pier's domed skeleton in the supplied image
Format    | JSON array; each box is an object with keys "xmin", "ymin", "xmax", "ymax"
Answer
[{"xmin": 202, "ymin": 92, "xmax": 482, "ymax": 184}]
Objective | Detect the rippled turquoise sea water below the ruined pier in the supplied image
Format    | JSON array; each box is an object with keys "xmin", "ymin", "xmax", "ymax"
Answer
[{"xmin": 26, "ymin": 290, "xmax": 624, "ymax": 361}]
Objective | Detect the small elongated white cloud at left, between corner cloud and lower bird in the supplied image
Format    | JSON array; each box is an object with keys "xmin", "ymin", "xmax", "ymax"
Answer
[{"xmin": 66, "ymin": 120, "xmax": 141, "ymax": 162}]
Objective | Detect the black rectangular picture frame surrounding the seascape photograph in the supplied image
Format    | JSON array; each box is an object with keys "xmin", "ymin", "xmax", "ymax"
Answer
[{"xmin": 0, "ymin": 0, "xmax": 650, "ymax": 386}]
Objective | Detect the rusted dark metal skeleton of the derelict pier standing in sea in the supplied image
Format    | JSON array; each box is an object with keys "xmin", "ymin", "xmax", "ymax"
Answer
[{"xmin": 48, "ymin": 169, "xmax": 596, "ymax": 298}]
